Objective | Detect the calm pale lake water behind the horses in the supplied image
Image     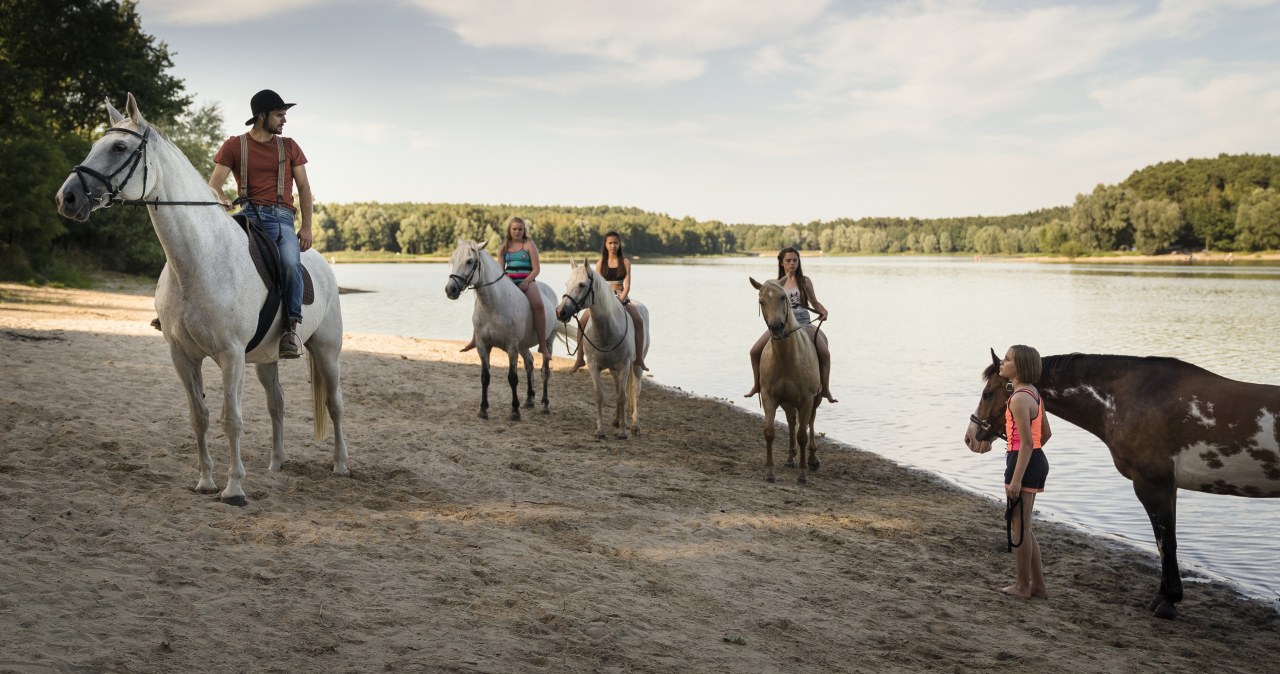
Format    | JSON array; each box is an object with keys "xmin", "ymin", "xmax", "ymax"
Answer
[{"xmin": 335, "ymin": 257, "xmax": 1280, "ymax": 600}]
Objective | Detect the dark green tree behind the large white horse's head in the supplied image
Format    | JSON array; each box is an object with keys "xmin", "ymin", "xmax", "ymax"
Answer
[{"xmin": 0, "ymin": 0, "xmax": 191, "ymax": 278}]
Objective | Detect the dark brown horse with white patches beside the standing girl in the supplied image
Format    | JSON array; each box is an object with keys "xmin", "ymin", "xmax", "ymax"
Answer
[{"xmin": 965, "ymin": 350, "xmax": 1280, "ymax": 618}]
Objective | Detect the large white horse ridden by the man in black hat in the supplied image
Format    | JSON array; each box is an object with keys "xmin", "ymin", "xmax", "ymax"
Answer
[{"xmin": 58, "ymin": 95, "xmax": 347, "ymax": 505}]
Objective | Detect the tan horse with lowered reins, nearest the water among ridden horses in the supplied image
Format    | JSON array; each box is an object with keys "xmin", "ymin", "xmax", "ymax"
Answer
[{"xmin": 751, "ymin": 279, "xmax": 822, "ymax": 483}]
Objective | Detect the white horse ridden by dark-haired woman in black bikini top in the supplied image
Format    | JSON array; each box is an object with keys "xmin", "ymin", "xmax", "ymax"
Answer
[{"xmin": 556, "ymin": 261, "xmax": 649, "ymax": 440}]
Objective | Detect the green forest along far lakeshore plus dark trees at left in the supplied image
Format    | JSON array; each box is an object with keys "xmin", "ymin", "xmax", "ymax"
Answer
[{"xmin": 0, "ymin": 0, "xmax": 1280, "ymax": 284}]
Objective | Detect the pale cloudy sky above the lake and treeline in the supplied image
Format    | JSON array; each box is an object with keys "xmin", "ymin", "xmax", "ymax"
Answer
[{"xmin": 132, "ymin": 0, "xmax": 1280, "ymax": 224}]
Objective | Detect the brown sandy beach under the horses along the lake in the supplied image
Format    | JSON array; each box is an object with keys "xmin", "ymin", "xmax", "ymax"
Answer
[{"xmin": 0, "ymin": 281, "xmax": 1280, "ymax": 673}]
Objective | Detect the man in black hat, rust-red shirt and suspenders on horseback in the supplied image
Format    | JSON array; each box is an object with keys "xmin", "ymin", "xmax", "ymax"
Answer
[{"xmin": 209, "ymin": 90, "xmax": 312, "ymax": 358}]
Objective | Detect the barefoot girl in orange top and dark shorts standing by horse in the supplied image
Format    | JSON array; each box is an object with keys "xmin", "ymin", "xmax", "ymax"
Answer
[{"xmin": 1000, "ymin": 344, "xmax": 1051, "ymax": 599}]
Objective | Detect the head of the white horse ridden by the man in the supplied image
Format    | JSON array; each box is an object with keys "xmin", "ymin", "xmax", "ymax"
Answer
[{"xmin": 56, "ymin": 93, "xmax": 159, "ymax": 221}]
